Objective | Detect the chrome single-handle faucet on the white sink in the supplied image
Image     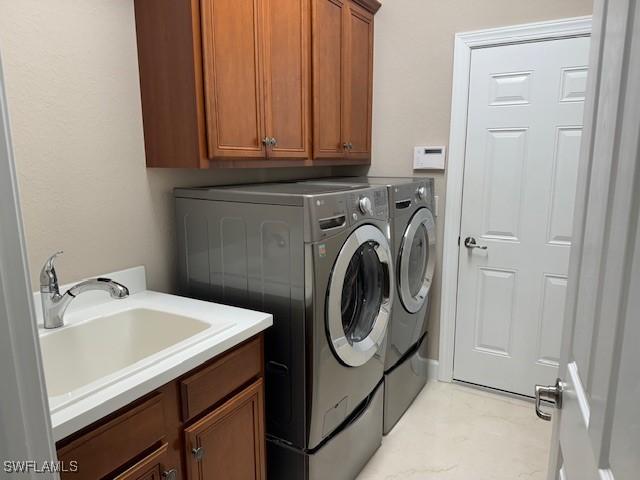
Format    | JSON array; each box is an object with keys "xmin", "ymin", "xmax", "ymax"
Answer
[{"xmin": 40, "ymin": 252, "xmax": 129, "ymax": 328}]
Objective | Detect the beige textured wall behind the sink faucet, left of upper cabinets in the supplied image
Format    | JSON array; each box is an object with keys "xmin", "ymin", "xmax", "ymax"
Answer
[{"xmin": 0, "ymin": 0, "xmax": 338, "ymax": 291}]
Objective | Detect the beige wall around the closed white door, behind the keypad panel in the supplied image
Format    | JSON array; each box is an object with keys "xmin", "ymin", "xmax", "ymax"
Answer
[{"xmin": 369, "ymin": 0, "xmax": 592, "ymax": 358}]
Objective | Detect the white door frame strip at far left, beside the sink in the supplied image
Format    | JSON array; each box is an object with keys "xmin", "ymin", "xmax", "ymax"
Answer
[{"xmin": 0, "ymin": 49, "xmax": 60, "ymax": 480}]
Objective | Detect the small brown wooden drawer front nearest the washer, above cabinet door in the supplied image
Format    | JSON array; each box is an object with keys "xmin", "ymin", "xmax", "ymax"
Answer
[{"xmin": 180, "ymin": 336, "xmax": 262, "ymax": 422}]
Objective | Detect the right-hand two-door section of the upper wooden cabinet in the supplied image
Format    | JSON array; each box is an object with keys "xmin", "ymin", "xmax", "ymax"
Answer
[{"xmin": 312, "ymin": 0, "xmax": 373, "ymax": 163}]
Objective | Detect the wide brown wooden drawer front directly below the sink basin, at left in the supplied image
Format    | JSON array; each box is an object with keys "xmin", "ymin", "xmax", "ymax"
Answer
[{"xmin": 58, "ymin": 393, "xmax": 165, "ymax": 480}]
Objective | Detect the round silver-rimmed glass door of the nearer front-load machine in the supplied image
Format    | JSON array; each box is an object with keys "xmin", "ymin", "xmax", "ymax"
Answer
[{"xmin": 326, "ymin": 225, "xmax": 394, "ymax": 367}]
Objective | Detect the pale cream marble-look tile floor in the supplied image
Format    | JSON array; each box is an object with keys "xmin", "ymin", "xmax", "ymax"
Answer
[{"xmin": 357, "ymin": 381, "xmax": 551, "ymax": 480}]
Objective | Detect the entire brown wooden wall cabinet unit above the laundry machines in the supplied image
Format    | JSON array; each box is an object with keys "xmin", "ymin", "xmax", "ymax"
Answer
[{"xmin": 135, "ymin": 0, "xmax": 380, "ymax": 168}]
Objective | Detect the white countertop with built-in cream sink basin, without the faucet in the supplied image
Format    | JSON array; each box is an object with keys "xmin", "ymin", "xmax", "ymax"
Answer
[{"xmin": 33, "ymin": 267, "xmax": 273, "ymax": 441}]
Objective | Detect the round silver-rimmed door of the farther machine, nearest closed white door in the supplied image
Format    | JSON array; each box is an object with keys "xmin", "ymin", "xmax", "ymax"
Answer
[{"xmin": 398, "ymin": 208, "xmax": 436, "ymax": 313}]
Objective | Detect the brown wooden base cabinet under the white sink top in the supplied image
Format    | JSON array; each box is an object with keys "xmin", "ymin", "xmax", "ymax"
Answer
[{"xmin": 56, "ymin": 335, "xmax": 266, "ymax": 480}]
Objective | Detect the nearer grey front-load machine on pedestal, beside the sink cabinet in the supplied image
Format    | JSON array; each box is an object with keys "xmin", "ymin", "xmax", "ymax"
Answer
[{"xmin": 175, "ymin": 183, "xmax": 395, "ymax": 480}]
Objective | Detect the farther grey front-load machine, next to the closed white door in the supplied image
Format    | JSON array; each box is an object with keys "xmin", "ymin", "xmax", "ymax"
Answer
[{"xmin": 305, "ymin": 177, "xmax": 436, "ymax": 434}]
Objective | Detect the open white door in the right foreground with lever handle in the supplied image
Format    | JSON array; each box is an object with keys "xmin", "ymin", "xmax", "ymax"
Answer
[{"xmin": 543, "ymin": 0, "xmax": 640, "ymax": 480}]
